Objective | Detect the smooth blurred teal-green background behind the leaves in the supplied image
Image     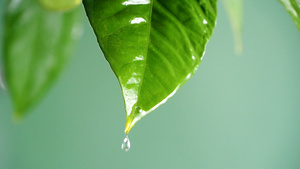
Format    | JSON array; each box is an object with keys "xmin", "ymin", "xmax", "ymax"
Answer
[{"xmin": 0, "ymin": 0, "xmax": 300, "ymax": 169}]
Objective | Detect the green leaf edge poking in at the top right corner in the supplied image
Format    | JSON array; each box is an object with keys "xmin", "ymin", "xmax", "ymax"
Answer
[{"xmin": 280, "ymin": 0, "xmax": 300, "ymax": 31}]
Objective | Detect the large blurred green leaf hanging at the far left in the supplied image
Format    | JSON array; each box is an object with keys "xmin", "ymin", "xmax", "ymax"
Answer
[{"xmin": 3, "ymin": 0, "xmax": 81, "ymax": 117}]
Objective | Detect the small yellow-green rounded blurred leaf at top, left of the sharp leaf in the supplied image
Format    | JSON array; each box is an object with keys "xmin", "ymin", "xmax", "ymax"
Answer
[{"xmin": 39, "ymin": 0, "xmax": 81, "ymax": 11}]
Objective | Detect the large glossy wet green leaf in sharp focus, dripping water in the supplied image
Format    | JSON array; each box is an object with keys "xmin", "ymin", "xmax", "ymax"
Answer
[{"xmin": 83, "ymin": 0, "xmax": 217, "ymax": 133}]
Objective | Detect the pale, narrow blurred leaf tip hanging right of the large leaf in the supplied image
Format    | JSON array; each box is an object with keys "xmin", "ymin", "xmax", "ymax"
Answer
[{"xmin": 223, "ymin": 0, "xmax": 243, "ymax": 55}]
